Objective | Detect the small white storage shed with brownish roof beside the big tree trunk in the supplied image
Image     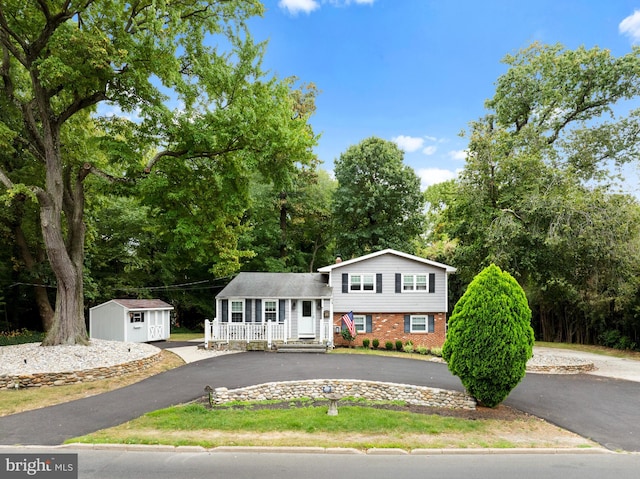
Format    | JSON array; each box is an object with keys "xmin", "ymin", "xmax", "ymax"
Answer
[{"xmin": 89, "ymin": 299, "xmax": 173, "ymax": 343}]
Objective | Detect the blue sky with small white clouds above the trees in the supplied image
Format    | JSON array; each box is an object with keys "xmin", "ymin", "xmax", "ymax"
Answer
[{"xmin": 250, "ymin": 0, "xmax": 640, "ymax": 187}]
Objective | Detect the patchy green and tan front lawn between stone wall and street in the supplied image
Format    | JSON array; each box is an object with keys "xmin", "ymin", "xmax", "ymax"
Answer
[{"xmin": 67, "ymin": 404, "xmax": 593, "ymax": 450}]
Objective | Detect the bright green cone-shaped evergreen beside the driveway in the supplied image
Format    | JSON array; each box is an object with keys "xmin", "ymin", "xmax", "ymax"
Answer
[{"xmin": 442, "ymin": 265, "xmax": 534, "ymax": 407}]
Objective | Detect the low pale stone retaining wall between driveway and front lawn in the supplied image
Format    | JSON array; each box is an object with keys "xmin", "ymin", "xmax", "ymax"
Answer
[{"xmin": 210, "ymin": 379, "xmax": 476, "ymax": 410}]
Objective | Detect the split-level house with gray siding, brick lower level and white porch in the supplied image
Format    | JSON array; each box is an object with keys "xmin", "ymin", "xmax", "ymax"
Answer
[{"xmin": 205, "ymin": 249, "xmax": 456, "ymax": 348}]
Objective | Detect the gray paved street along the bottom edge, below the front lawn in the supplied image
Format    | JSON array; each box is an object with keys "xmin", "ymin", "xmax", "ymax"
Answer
[{"xmin": 5, "ymin": 448, "xmax": 640, "ymax": 479}]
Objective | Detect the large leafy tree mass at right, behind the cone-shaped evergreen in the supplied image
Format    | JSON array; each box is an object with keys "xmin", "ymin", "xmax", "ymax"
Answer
[{"xmin": 429, "ymin": 44, "xmax": 640, "ymax": 342}]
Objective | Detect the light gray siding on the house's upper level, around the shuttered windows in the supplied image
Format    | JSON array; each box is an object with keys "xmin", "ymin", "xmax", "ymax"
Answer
[{"xmin": 330, "ymin": 254, "xmax": 447, "ymax": 313}]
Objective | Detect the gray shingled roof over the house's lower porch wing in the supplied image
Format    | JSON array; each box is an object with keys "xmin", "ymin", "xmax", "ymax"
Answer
[{"xmin": 217, "ymin": 273, "xmax": 331, "ymax": 298}]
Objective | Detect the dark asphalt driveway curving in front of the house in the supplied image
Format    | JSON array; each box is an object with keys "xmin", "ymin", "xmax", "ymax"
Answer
[{"xmin": 0, "ymin": 352, "xmax": 640, "ymax": 451}]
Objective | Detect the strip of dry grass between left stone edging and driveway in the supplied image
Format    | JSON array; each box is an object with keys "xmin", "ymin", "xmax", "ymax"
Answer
[{"xmin": 0, "ymin": 351, "xmax": 184, "ymax": 417}]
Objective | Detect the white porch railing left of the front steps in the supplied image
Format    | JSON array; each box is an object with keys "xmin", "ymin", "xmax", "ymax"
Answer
[{"xmin": 204, "ymin": 319, "xmax": 287, "ymax": 348}]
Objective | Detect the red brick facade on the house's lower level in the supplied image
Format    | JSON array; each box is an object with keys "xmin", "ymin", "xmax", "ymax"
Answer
[{"xmin": 333, "ymin": 311, "xmax": 446, "ymax": 349}]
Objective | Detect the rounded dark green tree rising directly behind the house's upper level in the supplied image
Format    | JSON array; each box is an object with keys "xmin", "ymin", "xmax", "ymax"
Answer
[{"xmin": 333, "ymin": 137, "xmax": 425, "ymax": 258}]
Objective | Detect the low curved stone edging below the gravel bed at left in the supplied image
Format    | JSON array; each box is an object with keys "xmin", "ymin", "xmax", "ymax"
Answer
[{"xmin": 0, "ymin": 350, "xmax": 162, "ymax": 389}]
